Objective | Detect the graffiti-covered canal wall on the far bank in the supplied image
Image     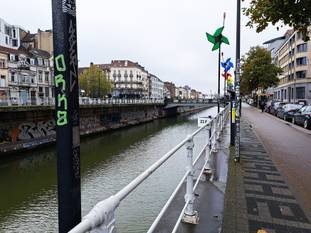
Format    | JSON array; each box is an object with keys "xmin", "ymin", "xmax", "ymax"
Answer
[{"xmin": 0, "ymin": 104, "xmax": 209, "ymax": 155}]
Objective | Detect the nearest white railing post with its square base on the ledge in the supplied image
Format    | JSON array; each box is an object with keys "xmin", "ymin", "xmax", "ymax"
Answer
[{"xmin": 182, "ymin": 137, "xmax": 199, "ymax": 224}]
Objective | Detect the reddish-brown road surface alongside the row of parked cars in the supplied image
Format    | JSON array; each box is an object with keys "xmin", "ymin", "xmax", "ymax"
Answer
[{"xmin": 242, "ymin": 104, "xmax": 311, "ymax": 219}]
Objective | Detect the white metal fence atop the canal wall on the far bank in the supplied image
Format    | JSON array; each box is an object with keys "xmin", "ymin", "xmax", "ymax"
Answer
[{"xmin": 0, "ymin": 97, "xmax": 164, "ymax": 107}]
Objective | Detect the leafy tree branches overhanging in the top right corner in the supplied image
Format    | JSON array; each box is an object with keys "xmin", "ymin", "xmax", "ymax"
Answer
[{"xmin": 244, "ymin": 0, "xmax": 311, "ymax": 40}]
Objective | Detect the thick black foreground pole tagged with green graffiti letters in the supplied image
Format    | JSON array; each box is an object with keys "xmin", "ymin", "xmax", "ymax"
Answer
[{"xmin": 52, "ymin": 0, "xmax": 81, "ymax": 233}]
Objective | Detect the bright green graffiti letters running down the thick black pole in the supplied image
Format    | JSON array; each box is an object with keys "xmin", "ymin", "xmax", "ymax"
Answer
[{"xmin": 55, "ymin": 54, "xmax": 68, "ymax": 126}]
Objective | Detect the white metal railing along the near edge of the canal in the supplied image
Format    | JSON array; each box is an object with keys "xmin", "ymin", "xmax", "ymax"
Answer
[{"xmin": 70, "ymin": 106, "xmax": 229, "ymax": 233}]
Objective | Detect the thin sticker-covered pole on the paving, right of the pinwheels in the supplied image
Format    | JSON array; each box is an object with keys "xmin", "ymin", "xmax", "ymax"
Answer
[{"xmin": 235, "ymin": 0, "xmax": 241, "ymax": 162}]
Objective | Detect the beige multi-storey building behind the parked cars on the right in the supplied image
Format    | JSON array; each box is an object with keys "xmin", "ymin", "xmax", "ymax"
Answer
[{"xmin": 265, "ymin": 30, "xmax": 311, "ymax": 104}]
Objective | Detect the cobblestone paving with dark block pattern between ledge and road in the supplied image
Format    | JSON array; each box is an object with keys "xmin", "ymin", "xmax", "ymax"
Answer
[{"xmin": 222, "ymin": 120, "xmax": 311, "ymax": 233}]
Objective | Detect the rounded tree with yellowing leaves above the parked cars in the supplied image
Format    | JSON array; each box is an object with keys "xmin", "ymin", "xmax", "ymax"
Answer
[{"xmin": 241, "ymin": 46, "xmax": 282, "ymax": 95}]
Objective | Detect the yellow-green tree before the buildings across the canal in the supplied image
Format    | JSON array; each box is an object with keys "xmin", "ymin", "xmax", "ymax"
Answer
[{"xmin": 79, "ymin": 64, "xmax": 113, "ymax": 98}]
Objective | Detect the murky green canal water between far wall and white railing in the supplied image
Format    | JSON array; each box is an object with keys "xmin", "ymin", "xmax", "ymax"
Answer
[{"xmin": 0, "ymin": 108, "xmax": 216, "ymax": 233}]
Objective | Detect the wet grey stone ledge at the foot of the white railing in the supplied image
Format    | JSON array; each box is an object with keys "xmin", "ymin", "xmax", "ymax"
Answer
[{"xmin": 154, "ymin": 122, "xmax": 230, "ymax": 233}]
